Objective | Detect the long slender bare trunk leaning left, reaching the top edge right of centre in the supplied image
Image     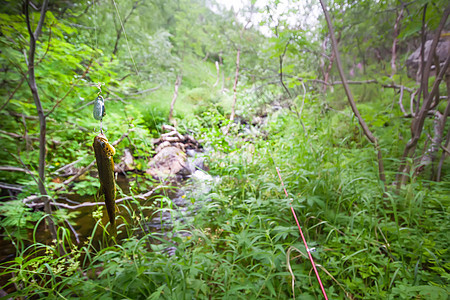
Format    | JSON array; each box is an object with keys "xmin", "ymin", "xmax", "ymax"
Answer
[{"xmin": 320, "ymin": 0, "xmax": 386, "ymax": 182}]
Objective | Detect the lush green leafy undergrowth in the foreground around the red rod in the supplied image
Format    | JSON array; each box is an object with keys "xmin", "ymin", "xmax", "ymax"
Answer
[{"xmin": 2, "ymin": 97, "xmax": 450, "ymax": 299}]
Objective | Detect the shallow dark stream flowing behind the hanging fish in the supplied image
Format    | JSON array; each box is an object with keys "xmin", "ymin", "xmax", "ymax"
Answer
[{"xmin": 0, "ymin": 153, "xmax": 216, "ymax": 262}]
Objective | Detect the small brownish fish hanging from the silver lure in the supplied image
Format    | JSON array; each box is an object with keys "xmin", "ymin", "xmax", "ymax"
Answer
[{"xmin": 93, "ymin": 133, "xmax": 116, "ymax": 235}]
